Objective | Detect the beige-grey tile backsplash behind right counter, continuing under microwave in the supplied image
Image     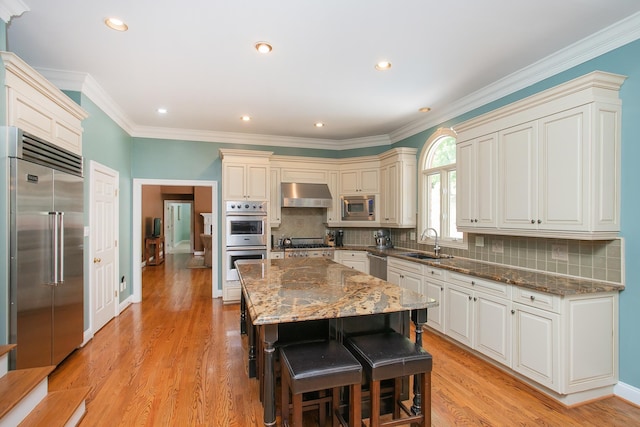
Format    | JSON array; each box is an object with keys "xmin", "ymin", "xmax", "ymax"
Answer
[{"xmin": 336, "ymin": 228, "xmax": 623, "ymax": 283}]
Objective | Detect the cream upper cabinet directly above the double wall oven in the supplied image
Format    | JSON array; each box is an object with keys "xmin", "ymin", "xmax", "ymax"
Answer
[{"xmin": 220, "ymin": 149, "xmax": 272, "ymax": 201}]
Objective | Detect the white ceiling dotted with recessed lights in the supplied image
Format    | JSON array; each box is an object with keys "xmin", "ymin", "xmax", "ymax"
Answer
[{"xmin": 3, "ymin": 0, "xmax": 640, "ymax": 149}]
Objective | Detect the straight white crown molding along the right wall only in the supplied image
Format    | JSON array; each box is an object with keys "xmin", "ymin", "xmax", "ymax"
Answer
[{"xmin": 389, "ymin": 13, "xmax": 640, "ymax": 143}]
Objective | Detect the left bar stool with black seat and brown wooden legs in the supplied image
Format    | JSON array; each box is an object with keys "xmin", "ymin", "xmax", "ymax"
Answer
[{"xmin": 280, "ymin": 340, "xmax": 362, "ymax": 427}]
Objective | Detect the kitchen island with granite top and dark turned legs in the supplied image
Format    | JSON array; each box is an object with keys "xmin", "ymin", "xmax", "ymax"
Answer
[{"xmin": 236, "ymin": 258, "xmax": 438, "ymax": 426}]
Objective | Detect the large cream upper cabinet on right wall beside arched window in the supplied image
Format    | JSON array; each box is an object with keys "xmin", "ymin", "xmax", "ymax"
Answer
[{"xmin": 456, "ymin": 71, "xmax": 625, "ymax": 239}]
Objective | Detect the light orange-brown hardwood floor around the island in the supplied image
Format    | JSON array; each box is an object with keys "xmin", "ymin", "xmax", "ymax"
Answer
[{"xmin": 50, "ymin": 254, "xmax": 640, "ymax": 427}]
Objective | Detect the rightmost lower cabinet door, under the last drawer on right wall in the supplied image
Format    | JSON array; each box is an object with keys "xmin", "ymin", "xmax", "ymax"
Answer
[{"xmin": 512, "ymin": 303, "xmax": 560, "ymax": 392}]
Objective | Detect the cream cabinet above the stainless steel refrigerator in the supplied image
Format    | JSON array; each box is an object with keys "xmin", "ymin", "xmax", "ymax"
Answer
[{"xmin": 0, "ymin": 52, "xmax": 88, "ymax": 155}]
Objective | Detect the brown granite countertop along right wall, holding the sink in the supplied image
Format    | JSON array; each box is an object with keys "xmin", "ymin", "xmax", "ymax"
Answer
[{"xmin": 336, "ymin": 246, "xmax": 624, "ymax": 295}]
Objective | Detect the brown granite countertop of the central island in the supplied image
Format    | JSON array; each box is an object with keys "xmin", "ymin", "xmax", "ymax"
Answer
[{"xmin": 236, "ymin": 258, "xmax": 438, "ymax": 325}]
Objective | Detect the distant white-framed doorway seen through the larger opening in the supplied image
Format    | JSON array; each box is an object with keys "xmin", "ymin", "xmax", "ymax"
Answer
[{"xmin": 164, "ymin": 200, "xmax": 194, "ymax": 254}]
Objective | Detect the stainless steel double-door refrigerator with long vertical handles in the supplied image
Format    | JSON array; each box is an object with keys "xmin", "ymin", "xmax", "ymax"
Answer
[{"xmin": 4, "ymin": 127, "xmax": 84, "ymax": 369}]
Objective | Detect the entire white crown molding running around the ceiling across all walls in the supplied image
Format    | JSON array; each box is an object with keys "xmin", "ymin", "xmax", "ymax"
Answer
[{"xmin": 36, "ymin": 11, "xmax": 640, "ymax": 150}]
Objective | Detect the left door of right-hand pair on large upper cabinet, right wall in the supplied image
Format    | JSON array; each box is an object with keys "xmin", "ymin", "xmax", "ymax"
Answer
[{"xmin": 498, "ymin": 121, "xmax": 539, "ymax": 229}]
